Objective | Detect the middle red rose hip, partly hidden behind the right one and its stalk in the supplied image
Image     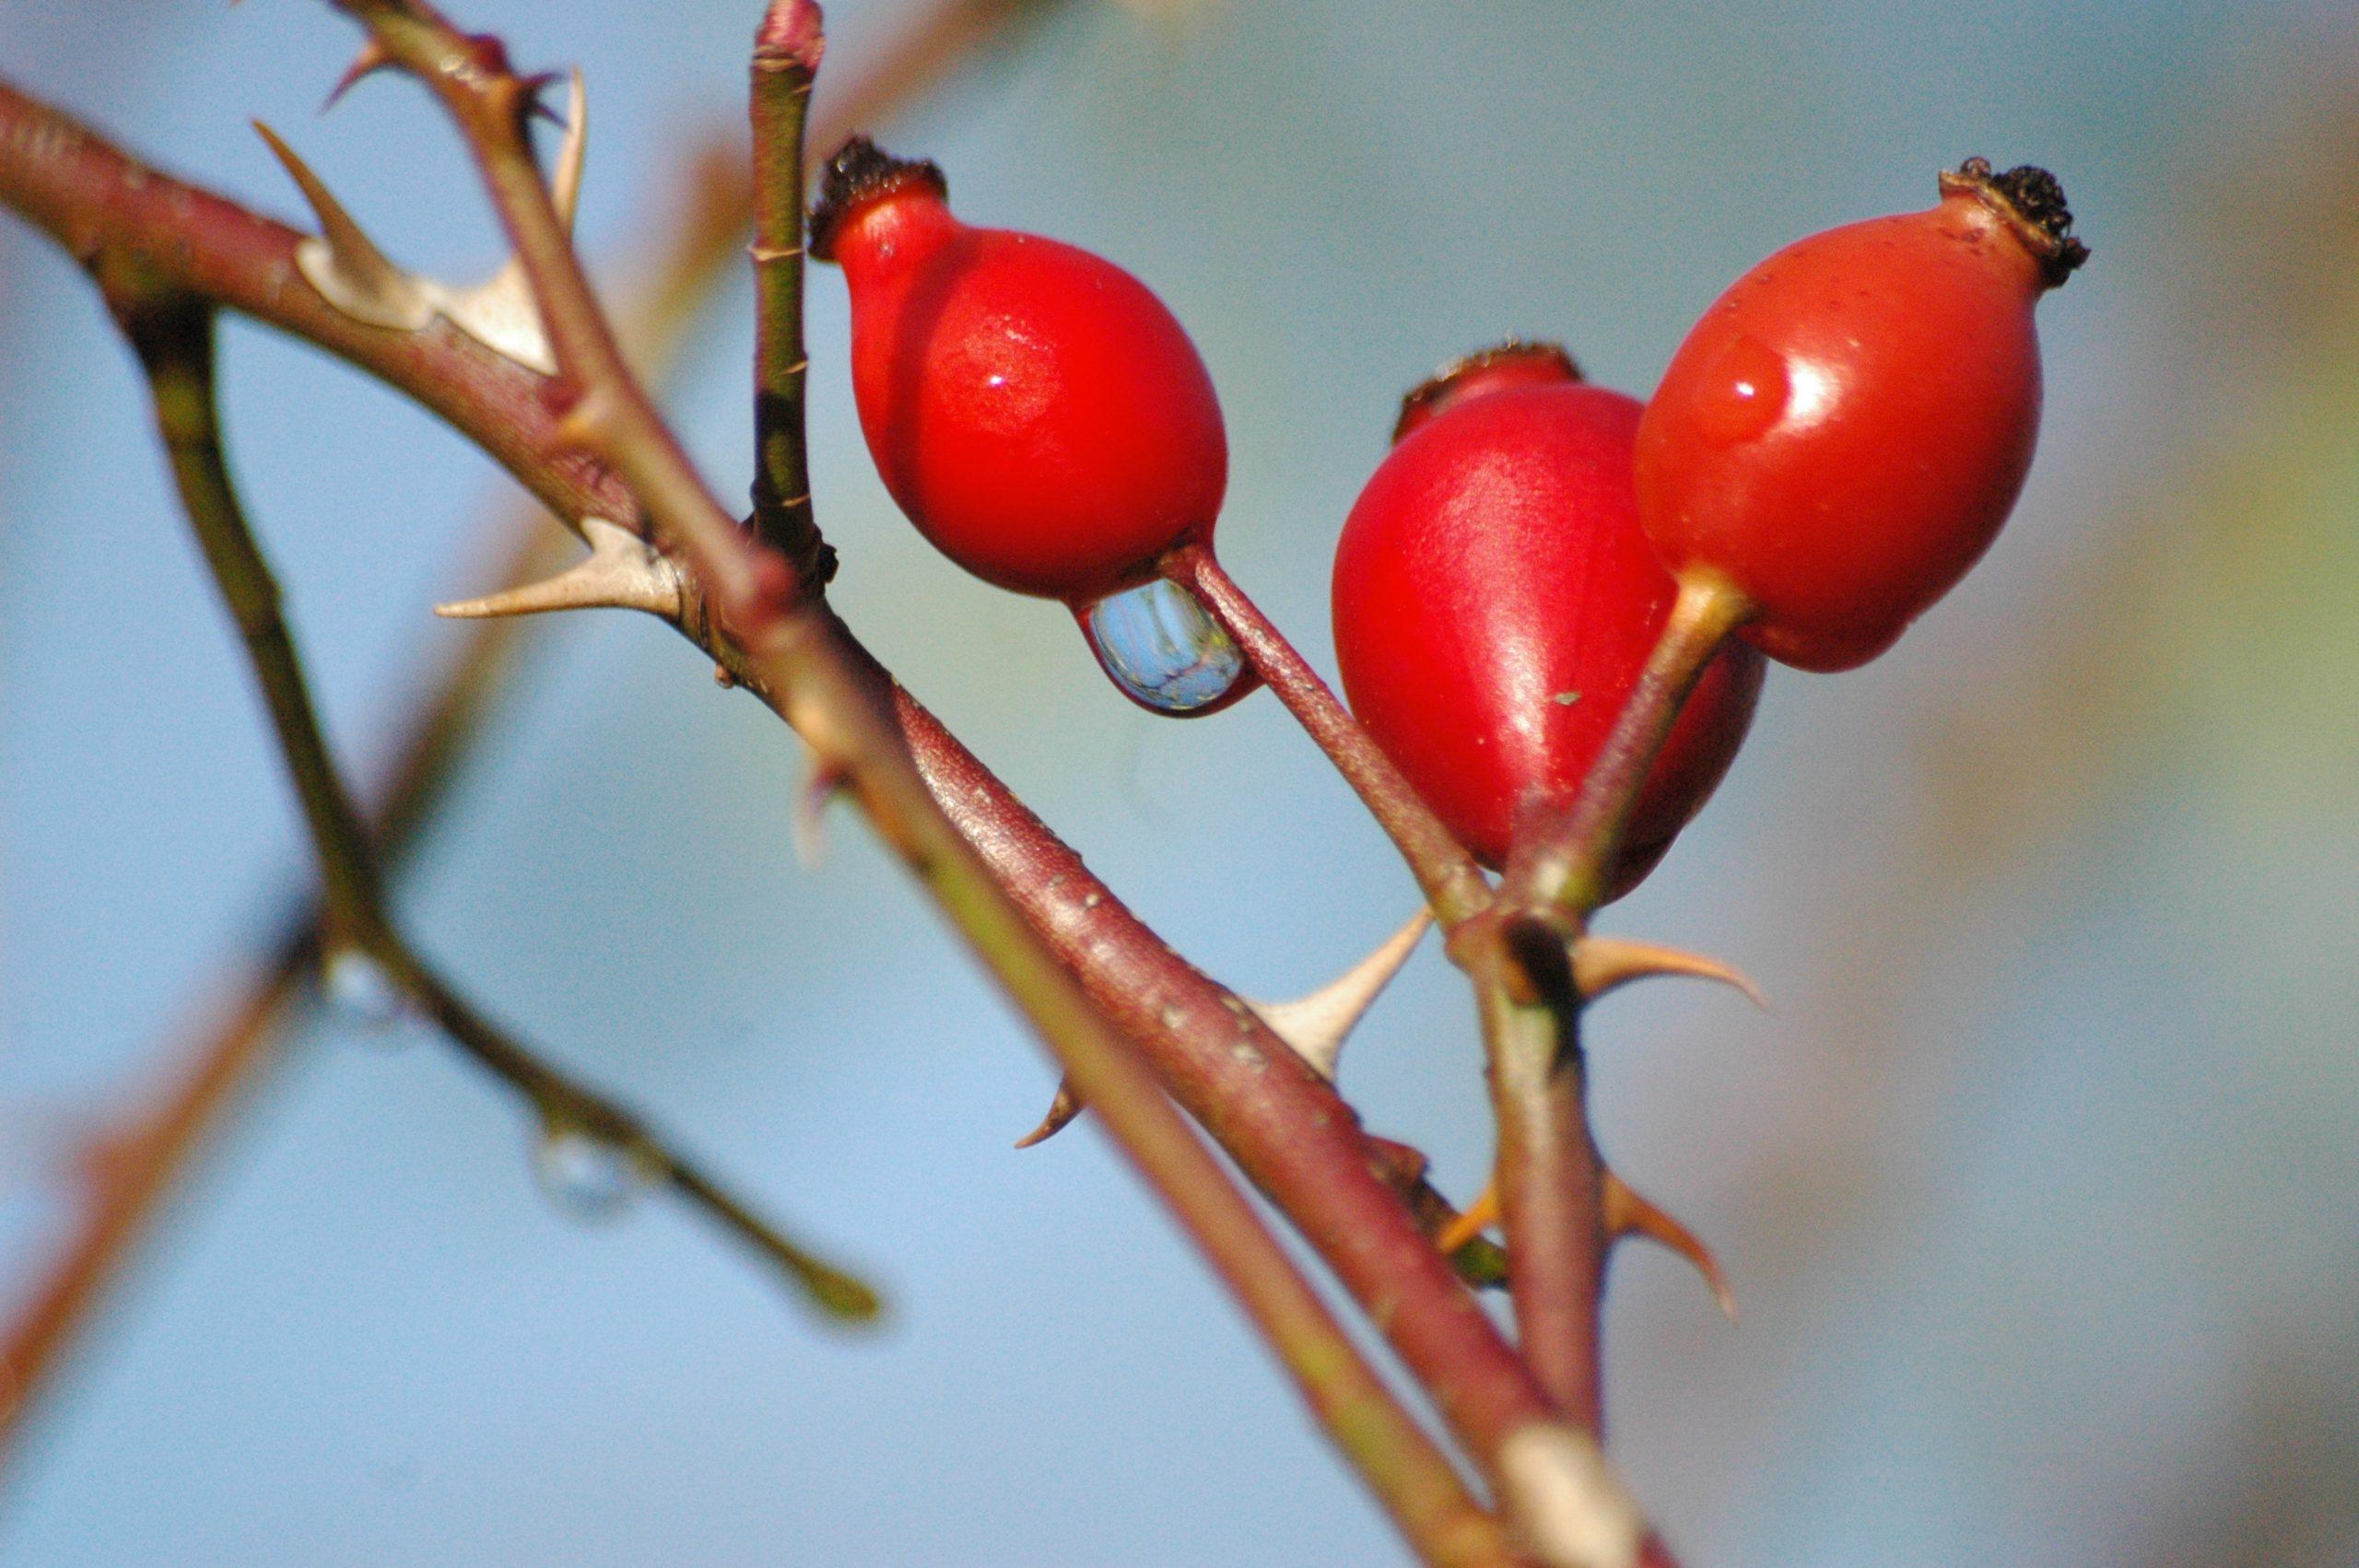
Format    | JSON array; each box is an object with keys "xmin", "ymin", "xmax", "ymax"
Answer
[{"xmin": 1332, "ymin": 345, "xmax": 1762, "ymax": 896}]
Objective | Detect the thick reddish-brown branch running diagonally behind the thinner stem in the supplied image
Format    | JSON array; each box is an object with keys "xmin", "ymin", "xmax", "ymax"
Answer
[{"xmin": 0, "ymin": 85, "xmax": 1641, "ymax": 1556}]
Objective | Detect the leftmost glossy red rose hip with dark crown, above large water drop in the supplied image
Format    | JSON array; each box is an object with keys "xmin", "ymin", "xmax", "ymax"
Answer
[{"xmin": 812, "ymin": 139, "xmax": 1229, "ymax": 606}]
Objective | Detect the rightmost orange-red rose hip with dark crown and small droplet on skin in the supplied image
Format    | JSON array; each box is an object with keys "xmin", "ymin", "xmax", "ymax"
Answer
[{"xmin": 1637, "ymin": 158, "xmax": 2088, "ymax": 670}]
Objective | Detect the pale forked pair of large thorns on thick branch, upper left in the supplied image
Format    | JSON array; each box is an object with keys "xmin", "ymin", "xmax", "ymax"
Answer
[{"xmin": 254, "ymin": 69, "xmax": 590, "ymax": 375}]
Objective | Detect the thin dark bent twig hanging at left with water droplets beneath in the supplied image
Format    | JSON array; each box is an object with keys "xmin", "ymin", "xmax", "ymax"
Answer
[{"xmin": 100, "ymin": 275, "xmax": 877, "ymax": 1318}]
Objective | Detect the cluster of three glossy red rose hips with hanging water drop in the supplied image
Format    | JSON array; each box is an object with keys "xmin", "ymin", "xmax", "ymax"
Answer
[{"xmin": 812, "ymin": 139, "xmax": 2088, "ymax": 896}]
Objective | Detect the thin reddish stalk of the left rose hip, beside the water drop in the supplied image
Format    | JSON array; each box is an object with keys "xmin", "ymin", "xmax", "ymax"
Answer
[{"xmin": 1163, "ymin": 544, "xmax": 1491, "ymax": 931}]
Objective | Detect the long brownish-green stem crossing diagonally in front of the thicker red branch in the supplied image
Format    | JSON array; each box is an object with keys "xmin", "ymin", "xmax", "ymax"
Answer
[{"xmin": 340, "ymin": 0, "xmax": 1512, "ymax": 1561}]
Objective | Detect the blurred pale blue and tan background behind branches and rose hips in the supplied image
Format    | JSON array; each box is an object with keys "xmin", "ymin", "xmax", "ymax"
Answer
[{"xmin": 0, "ymin": 0, "xmax": 2359, "ymax": 1568}]
